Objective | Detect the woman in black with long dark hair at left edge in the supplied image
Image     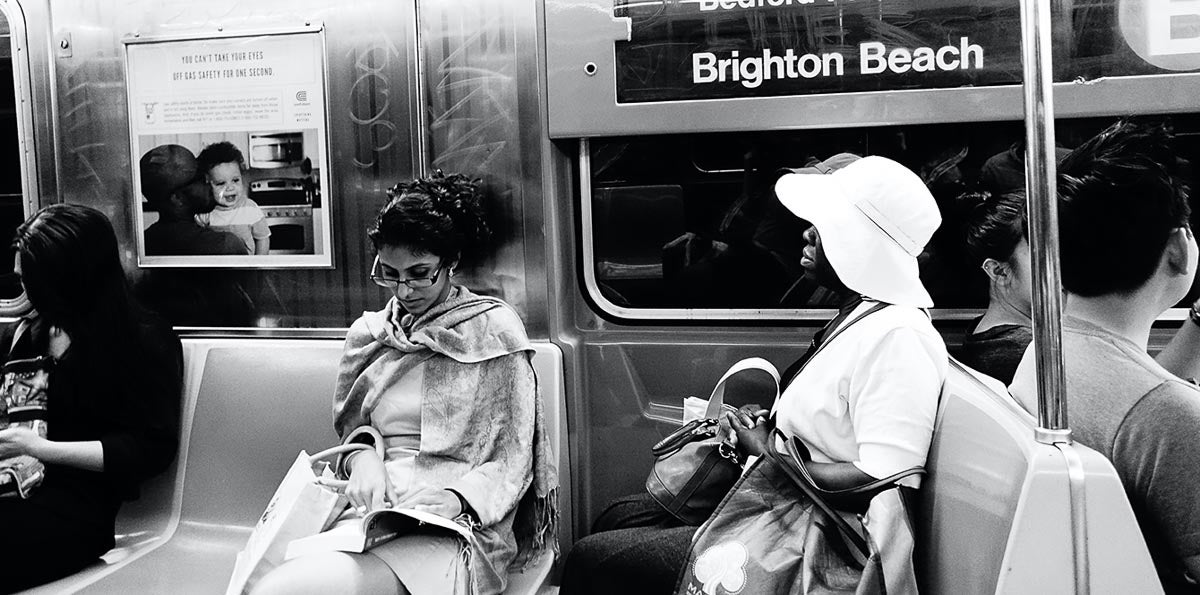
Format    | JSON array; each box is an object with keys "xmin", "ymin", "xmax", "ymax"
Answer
[{"xmin": 0, "ymin": 204, "xmax": 182, "ymax": 591}]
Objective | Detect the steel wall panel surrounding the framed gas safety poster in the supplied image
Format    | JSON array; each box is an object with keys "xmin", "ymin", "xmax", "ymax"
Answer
[{"xmin": 49, "ymin": 0, "xmax": 419, "ymax": 327}]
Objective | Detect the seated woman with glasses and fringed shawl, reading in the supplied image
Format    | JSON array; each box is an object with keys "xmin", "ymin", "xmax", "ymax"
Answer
[{"xmin": 254, "ymin": 172, "xmax": 557, "ymax": 595}]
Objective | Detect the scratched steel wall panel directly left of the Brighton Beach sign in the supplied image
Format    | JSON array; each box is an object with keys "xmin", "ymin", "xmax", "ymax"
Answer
[{"xmin": 418, "ymin": 0, "xmax": 547, "ymax": 336}]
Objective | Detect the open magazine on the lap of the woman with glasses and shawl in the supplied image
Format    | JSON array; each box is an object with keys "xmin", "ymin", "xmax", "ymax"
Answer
[{"xmin": 284, "ymin": 509, "xmax": 470, "ymax": 560}]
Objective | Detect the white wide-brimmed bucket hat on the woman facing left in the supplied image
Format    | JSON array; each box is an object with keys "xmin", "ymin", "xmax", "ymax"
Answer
[{"xmin": 775, "ymin": 157, "xmax": 942, "ymax": 308}]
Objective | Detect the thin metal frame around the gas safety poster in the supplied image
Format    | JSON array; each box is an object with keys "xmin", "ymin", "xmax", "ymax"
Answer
[{"xmin": 121, "ymin": 22, "xmax": 336, "ymax": 270}]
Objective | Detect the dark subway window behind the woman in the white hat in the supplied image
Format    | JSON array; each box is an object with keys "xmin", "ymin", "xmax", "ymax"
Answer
[{"xmin": 590, "ymin": 115, "xmax": 1200, "ymax": 309}]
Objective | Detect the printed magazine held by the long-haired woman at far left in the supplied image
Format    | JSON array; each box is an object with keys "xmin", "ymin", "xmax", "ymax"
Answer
[{"xmin": 0, "ymin": 356, "xmax": 54, "ymax": 498}]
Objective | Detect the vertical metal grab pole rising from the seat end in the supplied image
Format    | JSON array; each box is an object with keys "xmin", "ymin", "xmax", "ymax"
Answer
[{"xmin": 1021, "ymin": 0, "xmax": 1070, "ymax": 444}]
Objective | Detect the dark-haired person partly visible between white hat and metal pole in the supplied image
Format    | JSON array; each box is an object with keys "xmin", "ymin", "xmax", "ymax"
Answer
[{"xmin": 958, "ymin": 192, "xmax": 1033, "ymax": 385}]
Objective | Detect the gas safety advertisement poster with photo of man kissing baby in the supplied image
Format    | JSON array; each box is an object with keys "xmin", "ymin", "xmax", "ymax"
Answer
[{"xmin": 125, "ymin": 30, "xmax": 332, "ymax": 269}]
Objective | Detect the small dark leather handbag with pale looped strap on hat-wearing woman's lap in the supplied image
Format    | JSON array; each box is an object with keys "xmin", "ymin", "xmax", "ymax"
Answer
[{"xmin": 646, "ymin": 357, "xmax": 779, "ymax": 525}]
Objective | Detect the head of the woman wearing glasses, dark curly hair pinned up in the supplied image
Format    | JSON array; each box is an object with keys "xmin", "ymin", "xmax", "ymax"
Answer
[{"xmin": 367, "ymin": 172, "xmax": 491, "ymax": 315}]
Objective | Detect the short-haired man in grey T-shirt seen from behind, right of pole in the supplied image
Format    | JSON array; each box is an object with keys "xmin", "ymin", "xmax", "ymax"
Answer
[{"xmin": 1010, "ymin": 121, "xmax": 1200, "ymax": 593}]
